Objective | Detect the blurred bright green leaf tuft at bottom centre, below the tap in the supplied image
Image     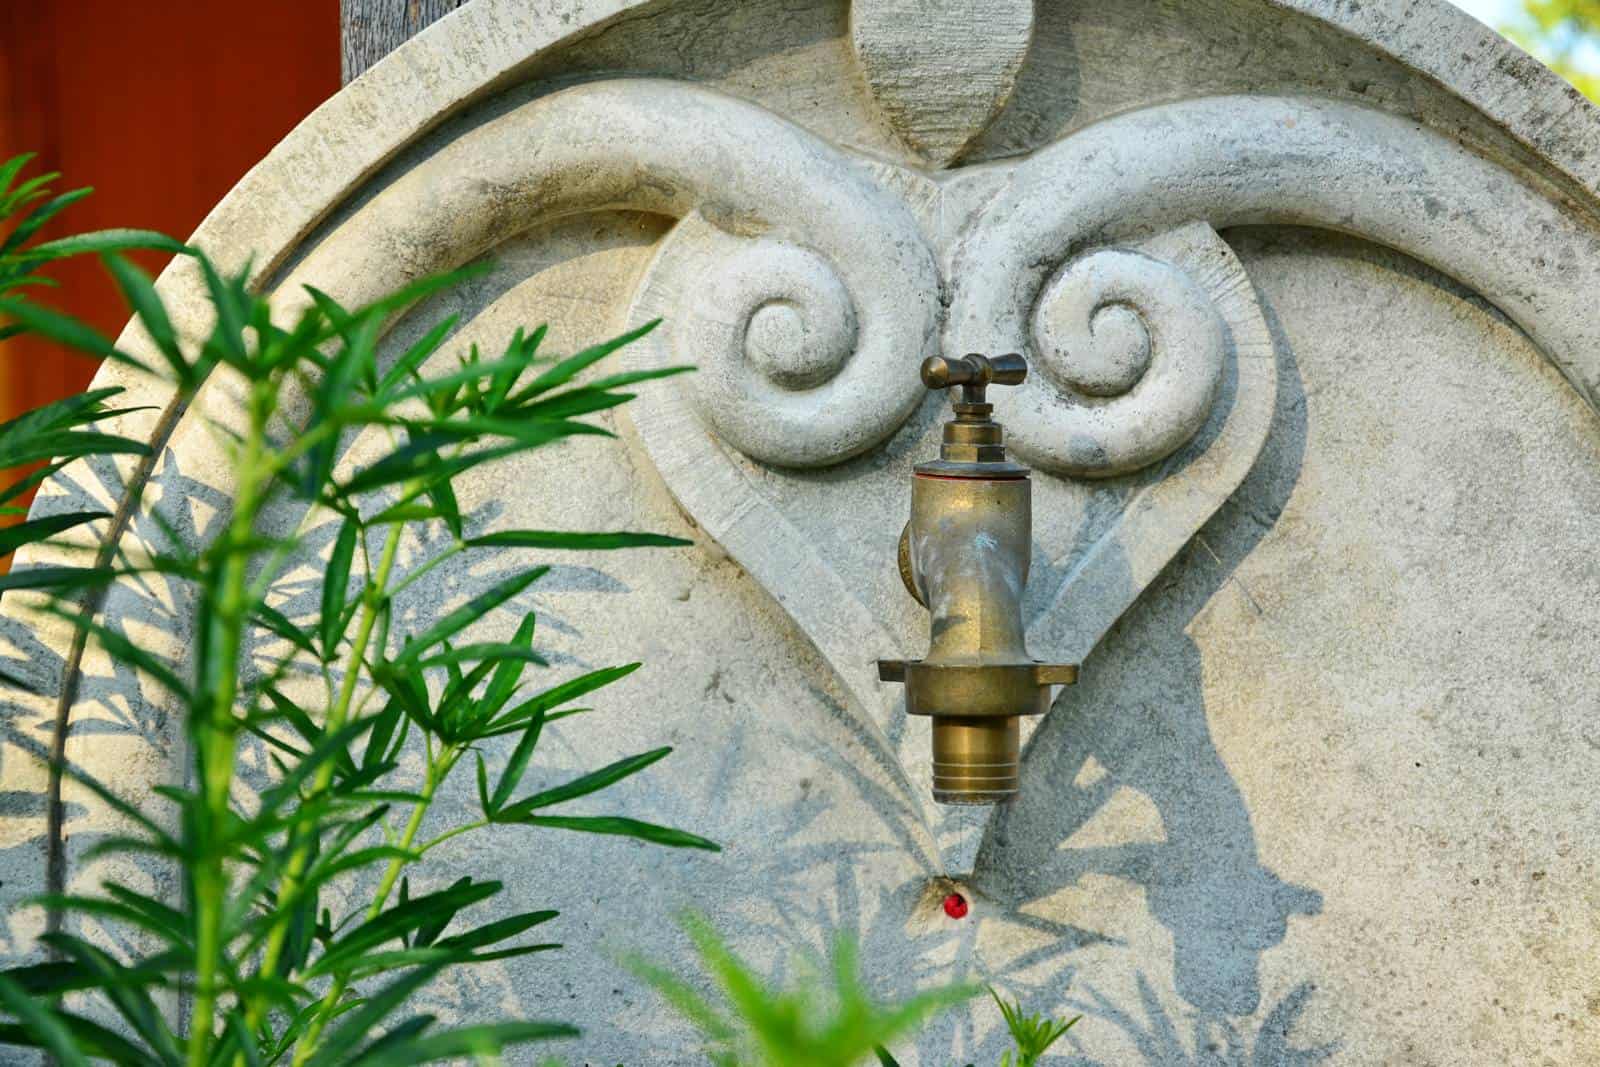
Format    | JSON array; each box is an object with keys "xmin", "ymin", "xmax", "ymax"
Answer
[{"xmin": 630, "ymin": 915, "xmax": 978, "ymax": 1067}]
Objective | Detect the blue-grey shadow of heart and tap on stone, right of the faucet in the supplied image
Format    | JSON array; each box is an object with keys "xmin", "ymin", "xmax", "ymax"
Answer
[{"xmin": 973, "ymin": 281, "xmax": 1328, "ymax": 1065}]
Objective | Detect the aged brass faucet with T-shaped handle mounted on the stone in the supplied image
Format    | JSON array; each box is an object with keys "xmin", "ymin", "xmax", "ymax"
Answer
[{"xmin": 878, "ymin": 354, "xmax": 1078, "ymax": 805}]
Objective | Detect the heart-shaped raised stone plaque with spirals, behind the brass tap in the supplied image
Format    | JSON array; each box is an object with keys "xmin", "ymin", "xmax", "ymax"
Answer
[{"xmin": 630, "ymin": 183, "xmax": 1277, "ymax": 870}]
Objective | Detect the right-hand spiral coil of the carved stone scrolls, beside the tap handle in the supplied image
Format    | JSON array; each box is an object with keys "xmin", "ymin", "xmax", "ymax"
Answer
[{"xmin": 1005, "ymin": 250, "xmax": 1227, "ymax": 477}]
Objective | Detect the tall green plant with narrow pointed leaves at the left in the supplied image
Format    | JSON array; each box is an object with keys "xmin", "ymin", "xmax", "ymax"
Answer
[{"xmin": 0, "ymin": 160, "xmax": 717, "ymax": 1067}]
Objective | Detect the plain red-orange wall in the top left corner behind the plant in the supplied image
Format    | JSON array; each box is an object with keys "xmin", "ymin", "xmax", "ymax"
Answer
[{"xmin": 0, "ymin": 0, "xmax": 339, "ymax": 418}]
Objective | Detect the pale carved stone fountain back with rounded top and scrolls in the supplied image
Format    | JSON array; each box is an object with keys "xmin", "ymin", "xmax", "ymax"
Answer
[{"xmin": 0, "ymin": 0, "xmax": 1600, "ymax": 1067}]
